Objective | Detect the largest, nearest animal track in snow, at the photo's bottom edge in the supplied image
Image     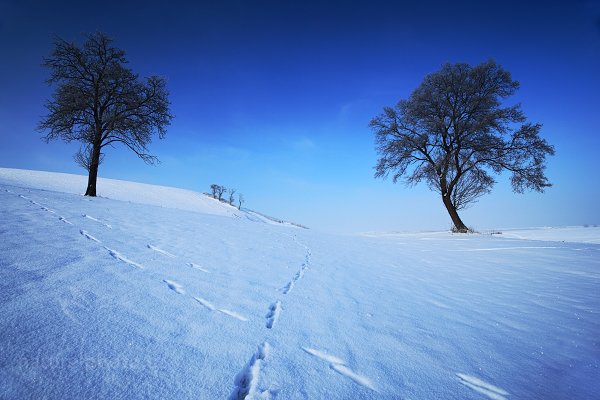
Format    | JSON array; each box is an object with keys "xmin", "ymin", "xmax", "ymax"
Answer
[{"xmin": 229, "ymin": 342, "xmax": 277, "ymax": 400}]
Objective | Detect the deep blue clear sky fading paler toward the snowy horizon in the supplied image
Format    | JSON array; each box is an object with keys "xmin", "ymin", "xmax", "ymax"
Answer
[{"xmin": 0, "ymin": 0, "xmax": 600, "ymax": 232}]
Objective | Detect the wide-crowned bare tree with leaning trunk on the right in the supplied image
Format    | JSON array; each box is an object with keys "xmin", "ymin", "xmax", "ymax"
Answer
[{"xmin": 369, "ymin": 61, "xmax": 554, "ymax": 232}]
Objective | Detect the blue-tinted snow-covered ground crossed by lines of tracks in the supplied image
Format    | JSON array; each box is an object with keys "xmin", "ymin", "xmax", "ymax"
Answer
[{"xmin": 0, "ymin": 169, "xmax": 600, "ymax": 399}]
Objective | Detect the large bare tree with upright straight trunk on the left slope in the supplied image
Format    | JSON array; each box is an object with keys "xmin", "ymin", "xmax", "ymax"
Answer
[{"xmin": 39, "ymin": 33, "xmax": 173, "ymax": 196}]
